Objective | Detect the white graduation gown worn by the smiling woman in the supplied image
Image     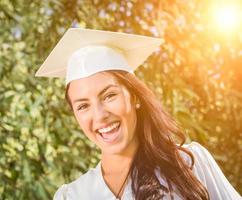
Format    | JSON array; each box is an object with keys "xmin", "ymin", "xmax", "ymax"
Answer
[{"xmin": 54, "ymin": 142, "xmax": 242, "ymax": 200}]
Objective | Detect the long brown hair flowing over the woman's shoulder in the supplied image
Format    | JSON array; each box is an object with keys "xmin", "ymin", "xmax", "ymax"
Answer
[{"xmin": 66, "ymin": 70, "xmax": 209, "ymax": 200}]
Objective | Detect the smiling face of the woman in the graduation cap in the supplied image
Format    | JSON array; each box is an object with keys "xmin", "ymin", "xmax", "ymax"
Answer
[{"xmin": 68, "ymin": 72, "xmax": 138, "ymax": 154}]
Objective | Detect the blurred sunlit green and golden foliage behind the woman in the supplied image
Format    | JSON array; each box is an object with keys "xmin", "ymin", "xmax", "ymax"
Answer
[{"xmin": 0, "ymin": 0, "xmax": 242, "ymax": 200}]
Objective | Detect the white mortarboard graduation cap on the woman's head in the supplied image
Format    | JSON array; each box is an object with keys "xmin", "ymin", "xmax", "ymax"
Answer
[{"xmin": 35, "ymin": 28, "xmax": 163, "ymax": 84}]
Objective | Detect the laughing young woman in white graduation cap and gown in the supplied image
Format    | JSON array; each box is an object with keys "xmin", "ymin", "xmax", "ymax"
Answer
[{"xmin": 37, "ymin": 29, "xmax": 241, "ymax": 200}]
